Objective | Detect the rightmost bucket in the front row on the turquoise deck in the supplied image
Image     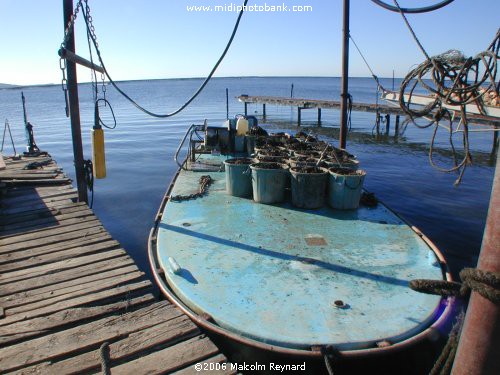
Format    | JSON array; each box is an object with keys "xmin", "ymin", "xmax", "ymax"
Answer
[{"xmin": 328, "ymin": 167, "xmax": 366, "ymax": 210}]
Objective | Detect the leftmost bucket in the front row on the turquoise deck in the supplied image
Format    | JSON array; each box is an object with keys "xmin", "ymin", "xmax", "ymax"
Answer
[{"xmin": 224, "ymin": 158, "xmax": 253, "ymax": 198}]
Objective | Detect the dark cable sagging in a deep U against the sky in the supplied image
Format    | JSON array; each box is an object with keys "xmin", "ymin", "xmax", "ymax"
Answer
[{"xmin": 74, "ymin": 0, "xmax": 248, "ymax": 118}]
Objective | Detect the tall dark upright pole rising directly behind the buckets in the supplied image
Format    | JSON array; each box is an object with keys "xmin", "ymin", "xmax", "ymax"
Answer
[{"xmin": 339, "ymin": 0, "xmax": 349, "ymax": 148}]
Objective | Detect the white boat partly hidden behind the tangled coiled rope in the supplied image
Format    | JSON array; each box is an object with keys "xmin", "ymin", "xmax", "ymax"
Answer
[{"xmin": 381, "ymin": 90, "xmax": 500, "ymax": 120}]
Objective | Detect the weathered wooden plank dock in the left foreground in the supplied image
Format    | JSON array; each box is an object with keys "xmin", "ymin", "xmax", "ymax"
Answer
[{"xmin": 0, "ymin": 156, "xmax": 230, "ymax": 374}]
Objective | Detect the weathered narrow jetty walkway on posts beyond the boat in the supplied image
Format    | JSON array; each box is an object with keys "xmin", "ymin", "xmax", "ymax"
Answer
[{"xmin": 237, "ymin": 95, "xmax": 500, "ymax": 126}]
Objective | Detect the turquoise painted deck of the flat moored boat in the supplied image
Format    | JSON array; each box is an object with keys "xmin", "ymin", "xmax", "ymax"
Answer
[{"xmin": 157, "ymin": 155, "xmax": 443, "ymax": 350}]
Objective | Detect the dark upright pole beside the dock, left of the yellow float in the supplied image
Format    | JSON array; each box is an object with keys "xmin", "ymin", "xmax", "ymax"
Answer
[{"xmin": 63, "ymin": 0, "xmax": 88, "ymax": 203}]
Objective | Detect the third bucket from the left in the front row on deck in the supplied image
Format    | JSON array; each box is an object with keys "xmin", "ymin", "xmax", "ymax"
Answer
[{"xmin": 290, "ymin": 166, "xmax": 328, "ymax": 209}]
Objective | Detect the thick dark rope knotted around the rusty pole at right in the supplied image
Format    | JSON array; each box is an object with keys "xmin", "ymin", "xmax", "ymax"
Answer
[{"xmin": 410, "ymin": 268, "xmax": 500, "ymax": 305}]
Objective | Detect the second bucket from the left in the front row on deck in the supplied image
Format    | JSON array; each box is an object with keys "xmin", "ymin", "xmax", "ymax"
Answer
[{"xmin": 250, "ymin": 162, "xmax": 288, "ymax": 204}]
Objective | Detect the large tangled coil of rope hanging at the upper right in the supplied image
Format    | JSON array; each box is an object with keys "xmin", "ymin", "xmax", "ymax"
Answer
[{"xmin": 394, "ymin": 0, "xmax": 500, "ymax": 185}]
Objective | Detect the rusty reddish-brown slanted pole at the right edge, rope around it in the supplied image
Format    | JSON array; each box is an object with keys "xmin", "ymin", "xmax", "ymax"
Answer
[{"xmin": 452, "ymin": 148, "xmax": 500, "ymax": 375}]
